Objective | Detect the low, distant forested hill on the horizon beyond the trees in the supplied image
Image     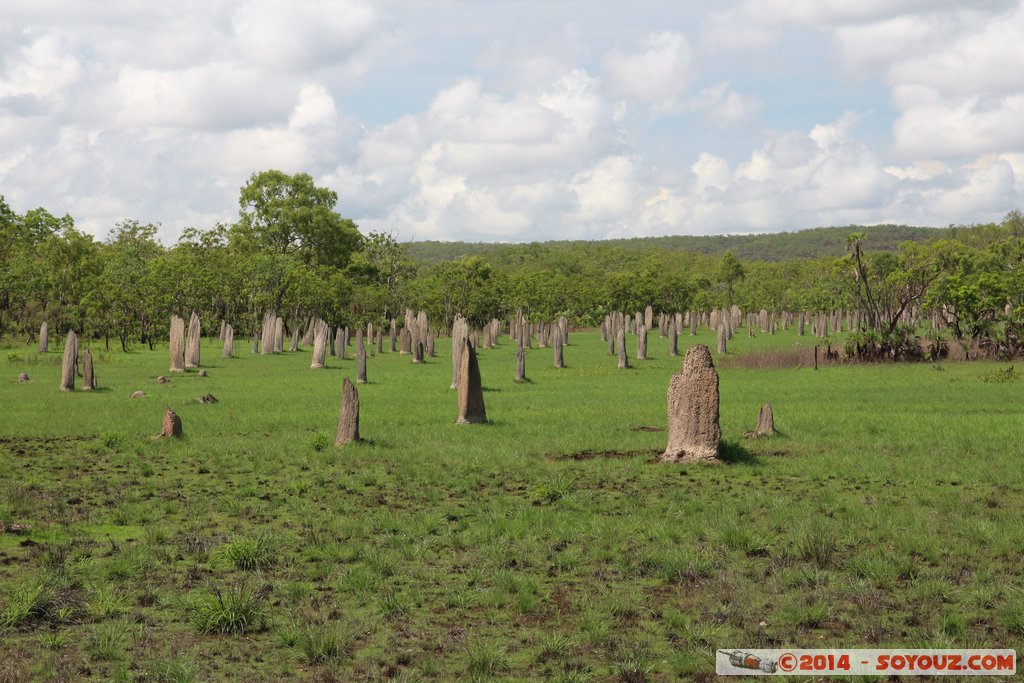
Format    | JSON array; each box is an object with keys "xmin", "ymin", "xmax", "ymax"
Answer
[{"xmin": 408, "ymin": 225, "xmax": 950, "ymax": 264}]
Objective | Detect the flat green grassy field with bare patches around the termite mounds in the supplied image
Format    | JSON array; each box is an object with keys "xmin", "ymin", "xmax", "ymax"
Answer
[{"xmin": 0, "ymin": 330, "xmax": 1024, "ymax": 681}]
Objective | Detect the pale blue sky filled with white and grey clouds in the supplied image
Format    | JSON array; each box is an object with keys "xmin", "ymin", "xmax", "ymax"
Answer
[{"xmin": 0, "ymin": 0, "xmax": 1024, "ymax": 244}]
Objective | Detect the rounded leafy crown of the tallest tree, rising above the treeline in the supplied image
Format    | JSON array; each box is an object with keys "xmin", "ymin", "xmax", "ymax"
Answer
[{"xmin": 233, "ymin": 170, "xmax": 362, "ymax": 268}]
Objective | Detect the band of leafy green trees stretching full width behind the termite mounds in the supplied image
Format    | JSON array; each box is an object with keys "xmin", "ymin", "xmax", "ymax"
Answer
[{"xmin": 0, "ymin": 171, "xmax": 1024, "ymax": 353}]
